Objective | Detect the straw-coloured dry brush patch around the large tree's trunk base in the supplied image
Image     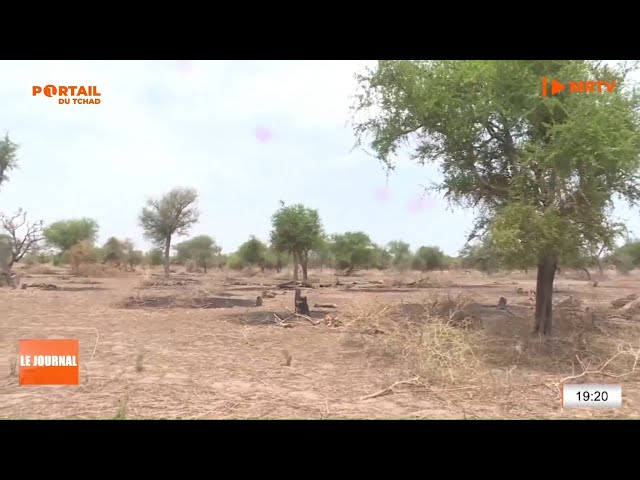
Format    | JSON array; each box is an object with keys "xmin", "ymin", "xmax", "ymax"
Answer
[{"xmin": 340, "ymin": 295, "xmax": 640, "ymax": 395}]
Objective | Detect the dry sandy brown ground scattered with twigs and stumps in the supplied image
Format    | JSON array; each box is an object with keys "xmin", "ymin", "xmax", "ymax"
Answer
[{"xmin": 0, "ymin": 267, "xmax": 640, "ymax": 419}]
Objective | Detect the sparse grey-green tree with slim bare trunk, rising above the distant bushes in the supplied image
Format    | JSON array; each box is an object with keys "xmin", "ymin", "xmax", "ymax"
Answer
[{"xmin": 139, "ymin": 187, "xmax": 200, "ymax": 278}]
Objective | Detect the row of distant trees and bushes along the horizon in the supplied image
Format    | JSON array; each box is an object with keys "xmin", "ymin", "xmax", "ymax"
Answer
[{"xmin": 5, "ymin": 188, "xmax": 456, "ymax": 280}]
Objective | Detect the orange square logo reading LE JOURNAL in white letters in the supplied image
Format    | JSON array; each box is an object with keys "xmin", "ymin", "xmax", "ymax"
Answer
[{"xmin": 20, "ymin": 340, "xmax": 80, "ymax": 385}]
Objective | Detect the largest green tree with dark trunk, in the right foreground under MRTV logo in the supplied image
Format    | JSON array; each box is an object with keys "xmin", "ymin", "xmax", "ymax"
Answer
[{"xmin": 354, "ymin": 60, "xmax": 640, "ymax": 334}]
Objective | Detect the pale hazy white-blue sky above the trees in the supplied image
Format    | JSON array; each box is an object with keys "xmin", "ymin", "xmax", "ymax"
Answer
[{"xmin": 0, "ymin": 60, "xmax": 640, "ymax": 255}]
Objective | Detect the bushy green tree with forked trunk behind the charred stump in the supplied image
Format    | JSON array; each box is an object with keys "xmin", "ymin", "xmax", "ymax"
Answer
[{"xmin": 271, "ymin": 202, "xmax": 323, "ymax": 280}]
